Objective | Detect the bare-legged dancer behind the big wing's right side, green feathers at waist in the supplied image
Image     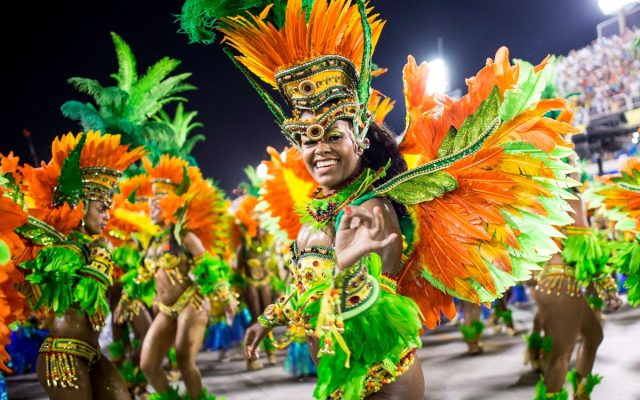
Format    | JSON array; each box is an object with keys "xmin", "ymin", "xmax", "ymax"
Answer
[{"xmin": 529, "ymin": 153, "xmax": 621, "ymax": 400}]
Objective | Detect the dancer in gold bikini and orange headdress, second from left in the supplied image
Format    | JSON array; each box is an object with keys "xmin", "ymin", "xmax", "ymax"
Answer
[{"xmin": 140, "ymin": 155, "xmax": 237, "ymax": 399}]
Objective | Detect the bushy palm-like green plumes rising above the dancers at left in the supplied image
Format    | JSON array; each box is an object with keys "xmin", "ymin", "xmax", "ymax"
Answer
[{"xmin": 61, "ymin": 33, "xmax": 205, "ymax": 164}]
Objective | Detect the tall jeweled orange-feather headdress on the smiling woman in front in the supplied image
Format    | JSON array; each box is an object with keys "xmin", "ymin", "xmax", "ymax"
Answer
[{"xmin": 181, "ymin": 0, "xmax": 384, "ymax": 149}]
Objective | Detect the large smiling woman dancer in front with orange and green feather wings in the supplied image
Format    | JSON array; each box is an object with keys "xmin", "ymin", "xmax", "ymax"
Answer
[{"xmin": 182, "ymin": 0, "xmax": 571, "ymax": 400}]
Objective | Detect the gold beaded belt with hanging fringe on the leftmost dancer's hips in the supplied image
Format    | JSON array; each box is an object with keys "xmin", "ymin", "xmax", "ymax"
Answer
[{"xmin": 39, "ymin": 337, "xmax": 101, "ymax": 390}]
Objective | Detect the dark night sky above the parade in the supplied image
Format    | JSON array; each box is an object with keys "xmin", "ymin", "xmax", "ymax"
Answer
[{"xmin": 0, "ymin": 0, "xmax": 606, "ymax": 190}]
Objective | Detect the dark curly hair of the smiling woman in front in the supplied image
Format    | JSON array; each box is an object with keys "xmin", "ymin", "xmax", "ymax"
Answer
[{"xmin": 361, "ymin": 123, "xmax": 408, "ymax": 218}]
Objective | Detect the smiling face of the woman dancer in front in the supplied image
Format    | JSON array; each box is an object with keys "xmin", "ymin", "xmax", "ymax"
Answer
[{"xmin": 301, "ymin": 112, "xmax": 362, "ymax": 190}]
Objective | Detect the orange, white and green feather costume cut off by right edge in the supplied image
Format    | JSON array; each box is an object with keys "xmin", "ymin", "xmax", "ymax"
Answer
[{"xmin": 585, "ymin": 157, "xmax": 640, "ymax": 306}]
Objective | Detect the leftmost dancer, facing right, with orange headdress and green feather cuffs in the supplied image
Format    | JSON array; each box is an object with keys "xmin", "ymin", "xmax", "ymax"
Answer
[{"xmin": 9, "ymin": 132, "xmax": 144, "ymax": 400}]
